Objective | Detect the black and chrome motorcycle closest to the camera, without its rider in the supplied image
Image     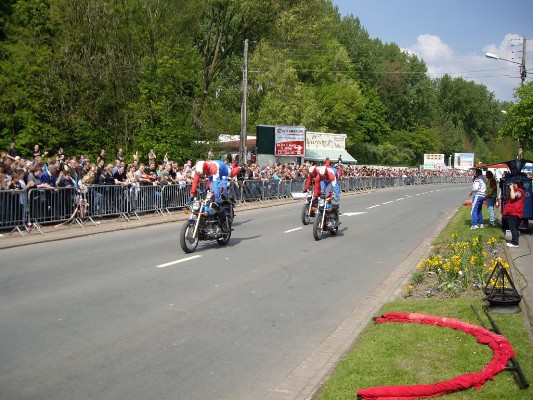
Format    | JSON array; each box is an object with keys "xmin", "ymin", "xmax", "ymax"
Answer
[{"xmin": 180, "ymin": 191, "xmax": 235, "ymax": 253}]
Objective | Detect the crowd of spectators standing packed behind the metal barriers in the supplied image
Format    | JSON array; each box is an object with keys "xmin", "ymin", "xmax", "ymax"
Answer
[{"xmin": 0, "ymin": 143, "xmax": 474, "ymax": 190}]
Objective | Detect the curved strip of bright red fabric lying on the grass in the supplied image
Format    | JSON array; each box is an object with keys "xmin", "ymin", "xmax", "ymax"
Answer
[{"xmin": 357, "ymin": 312, "xmax": 515, "ymax": 400}]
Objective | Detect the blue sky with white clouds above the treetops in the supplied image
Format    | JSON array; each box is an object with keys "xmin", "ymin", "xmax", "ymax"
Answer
[{"xmin": 333, "ymin": 0, "xmax": 533, "ymax": 101}]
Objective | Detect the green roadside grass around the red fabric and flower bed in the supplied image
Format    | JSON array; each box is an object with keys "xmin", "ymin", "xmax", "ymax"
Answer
[{"xmin": 315, "ymin": 207, "xmax": 533, "ymax": 400}]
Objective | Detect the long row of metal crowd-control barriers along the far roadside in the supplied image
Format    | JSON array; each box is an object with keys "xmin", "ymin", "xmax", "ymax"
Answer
[{"xmin": 0, "ymin": 176, "xmax": 471, "ymax": 235}]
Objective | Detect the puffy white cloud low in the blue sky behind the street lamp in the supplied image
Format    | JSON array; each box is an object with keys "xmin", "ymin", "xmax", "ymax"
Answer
[{"xmin": 404, "ymin": 34, "xmax": 522, "ymax": 101}]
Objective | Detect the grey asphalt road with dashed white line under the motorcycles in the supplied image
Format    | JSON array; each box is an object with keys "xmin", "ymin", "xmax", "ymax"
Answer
[{"xmin": 0, "ymin": 185, "xmax": 469, "ymax": 400}]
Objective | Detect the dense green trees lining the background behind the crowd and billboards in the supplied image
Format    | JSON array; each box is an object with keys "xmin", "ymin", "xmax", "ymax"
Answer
[{"xmin": 0, "ymin": 0, "xmax": 532, "ymax": 165}]
